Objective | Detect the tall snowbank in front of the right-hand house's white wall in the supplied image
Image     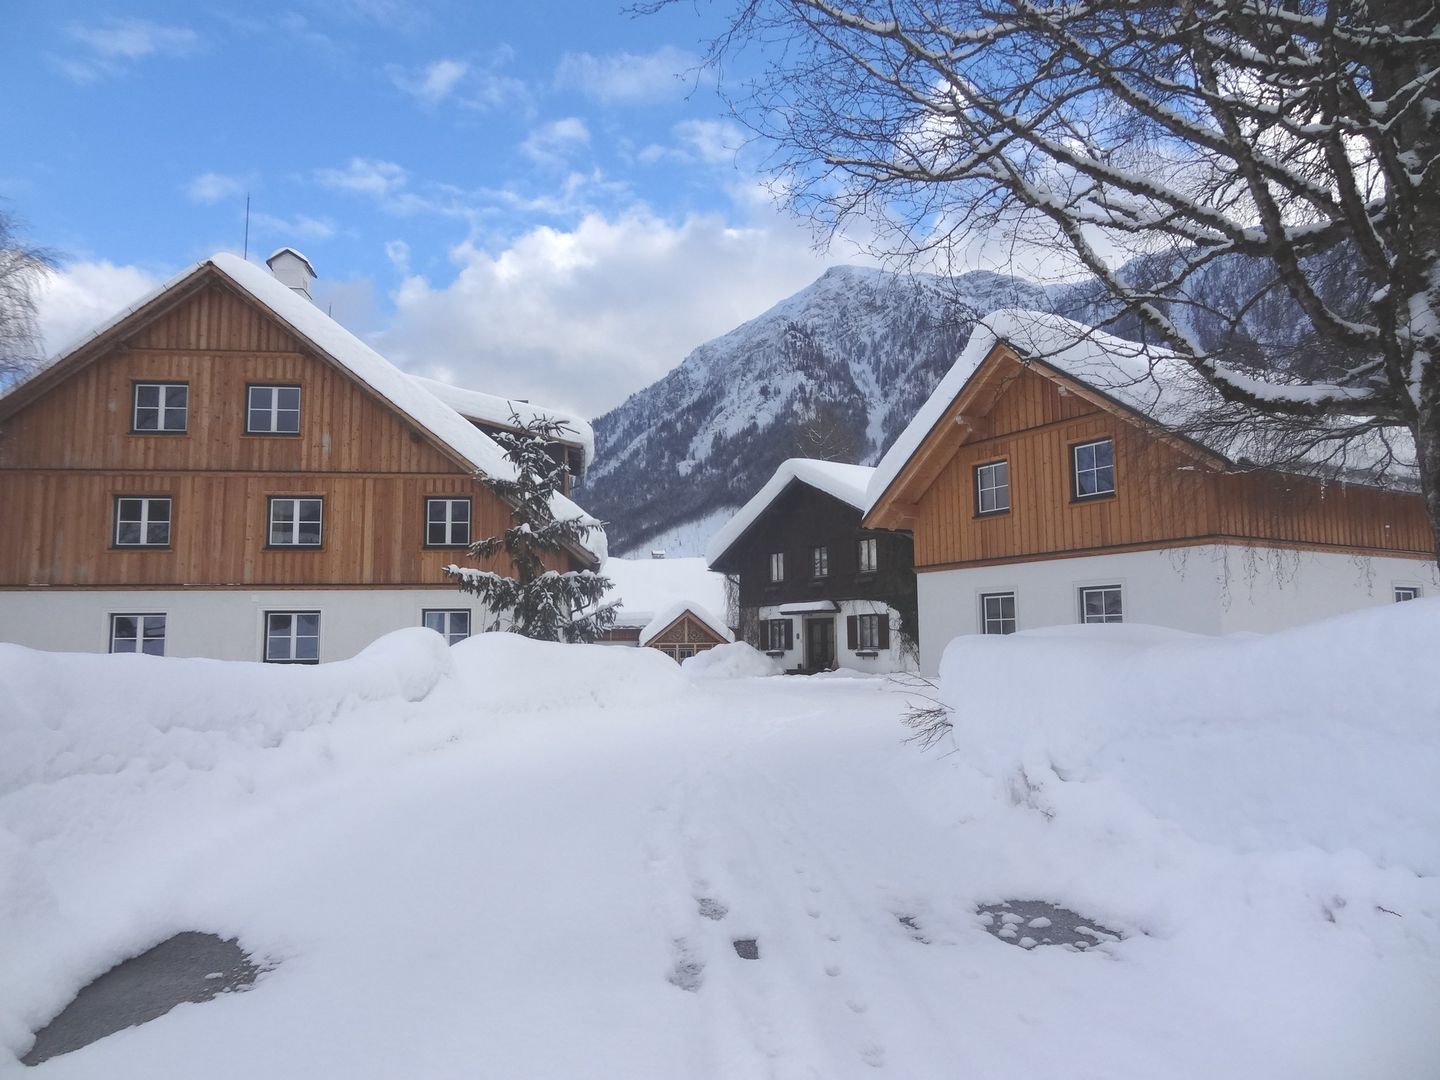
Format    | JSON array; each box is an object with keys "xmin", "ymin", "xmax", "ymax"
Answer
[{"xmin": 940, "ymin": 599, "xmax": 1440, "ymax": 874}]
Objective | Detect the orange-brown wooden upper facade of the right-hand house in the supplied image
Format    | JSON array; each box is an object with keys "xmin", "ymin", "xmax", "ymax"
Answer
[{"xmin": 865, "ymin": 343, "xmax": 1431, "ymax": 570}]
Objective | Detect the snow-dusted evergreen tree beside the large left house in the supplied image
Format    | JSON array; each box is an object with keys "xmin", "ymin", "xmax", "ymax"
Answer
[{"xmin": 445, "ymin": 413, "xmax": 615, "ymax": 642}]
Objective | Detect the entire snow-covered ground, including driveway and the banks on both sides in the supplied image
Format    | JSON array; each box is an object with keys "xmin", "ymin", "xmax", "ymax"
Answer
[{"xmin": 0, "ymin": 600, "xmax": 1440, "ymax": 1080}]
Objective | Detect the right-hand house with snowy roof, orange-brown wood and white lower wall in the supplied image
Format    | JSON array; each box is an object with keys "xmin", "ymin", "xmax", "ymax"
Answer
[{"xmin": 864, "ymin": 311, "xmax": 1436, "ymax": 671}]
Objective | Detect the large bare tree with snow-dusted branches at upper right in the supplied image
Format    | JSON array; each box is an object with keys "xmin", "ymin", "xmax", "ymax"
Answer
[{"xmin": 655, "ymin": 0, "xmax": 1440, "ymax": 567}]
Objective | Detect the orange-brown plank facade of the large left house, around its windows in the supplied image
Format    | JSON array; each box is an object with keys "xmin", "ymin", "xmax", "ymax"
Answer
[{"xmin": 0, "ymin": 268, "xmax": 582, "ymax": 590}]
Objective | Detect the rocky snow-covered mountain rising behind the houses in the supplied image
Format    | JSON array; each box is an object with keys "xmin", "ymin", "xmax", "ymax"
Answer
[{"xmin": 577, "ymin": 261, "xmax": 1324, "ymax": 554}]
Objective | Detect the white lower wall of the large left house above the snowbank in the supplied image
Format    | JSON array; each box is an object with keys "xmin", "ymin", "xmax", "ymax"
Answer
[{"xmin": 0, "ymin": 589, "xmax": 485, "ymax": 661}]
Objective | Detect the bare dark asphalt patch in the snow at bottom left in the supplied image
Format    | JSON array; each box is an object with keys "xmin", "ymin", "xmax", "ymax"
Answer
[{"xmin": 20, "ymin": 930, "xmax": 262, "ymax": 1066}]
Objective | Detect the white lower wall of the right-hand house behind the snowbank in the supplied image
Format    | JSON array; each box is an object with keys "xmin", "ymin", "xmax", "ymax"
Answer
[{"xmin": 919, "ymin": 544, "xmax": 1440, "ymax": 674}]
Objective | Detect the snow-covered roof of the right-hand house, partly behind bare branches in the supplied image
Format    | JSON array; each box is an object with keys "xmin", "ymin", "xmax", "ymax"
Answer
[{"xmin": 865, "ymin": 308, "xmax": 1416, "ymax": 513}]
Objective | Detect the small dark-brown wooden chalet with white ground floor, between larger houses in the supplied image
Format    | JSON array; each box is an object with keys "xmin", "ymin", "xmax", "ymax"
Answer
[{"xmin": 706, "ymin": 458, "xmax": 916, "ymax": 672}]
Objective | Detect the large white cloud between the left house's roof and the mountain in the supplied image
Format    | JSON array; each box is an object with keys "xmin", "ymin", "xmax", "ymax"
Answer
[{"xmin": 376, "ymin": 209, "xmax": 825, "ymax": 416}]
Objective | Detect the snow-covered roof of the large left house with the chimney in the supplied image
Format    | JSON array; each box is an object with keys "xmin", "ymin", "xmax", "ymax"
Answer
[{"xmin": 0, "ymin": 252, "xmax": 606, "ymax": 562}]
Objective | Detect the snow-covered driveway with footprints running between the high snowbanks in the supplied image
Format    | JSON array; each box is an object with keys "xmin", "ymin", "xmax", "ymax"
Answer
[{"xmin": 0, "ymin": 668, "xmax": 1433, "ymax": 1080}]
